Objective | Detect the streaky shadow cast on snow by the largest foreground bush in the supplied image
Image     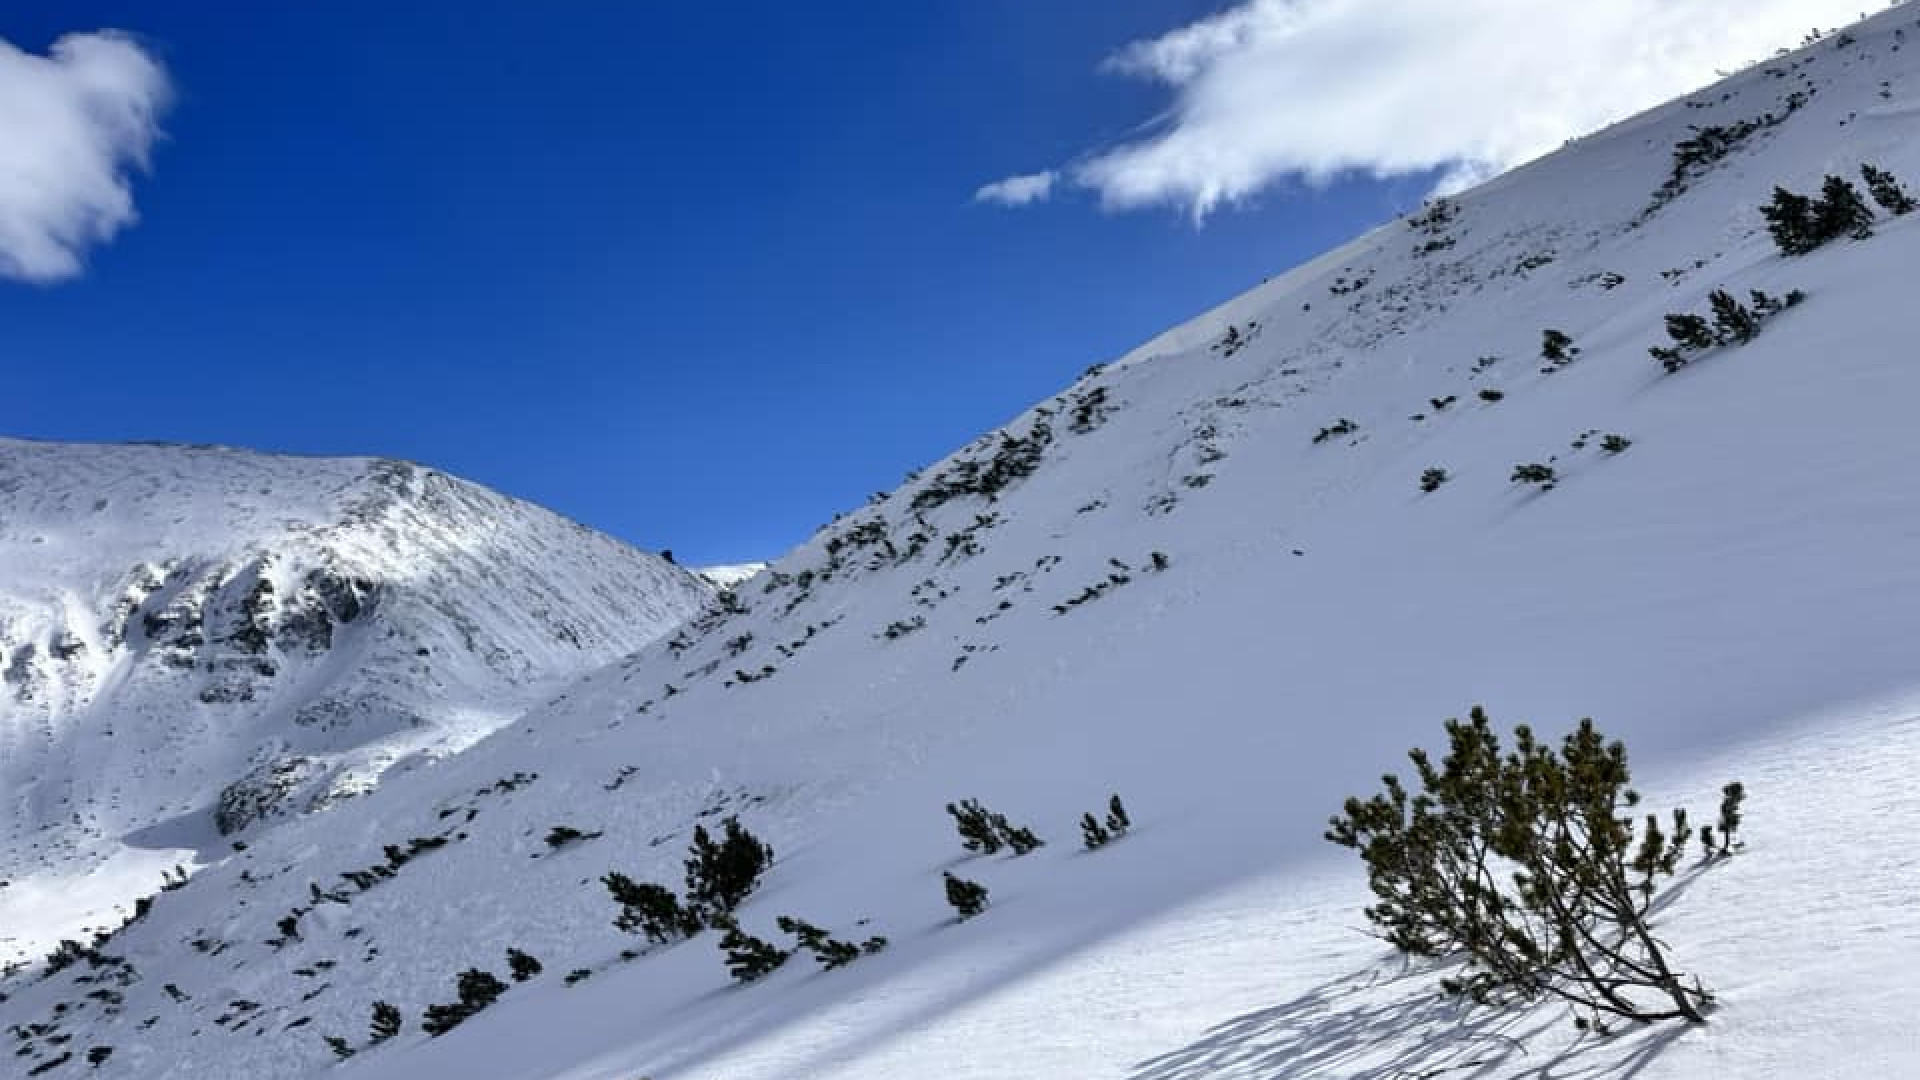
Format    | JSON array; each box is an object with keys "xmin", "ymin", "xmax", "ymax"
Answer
[{"xmin": 1127, "ymin": 959, "xmax": 1686, "ymax": 1080}]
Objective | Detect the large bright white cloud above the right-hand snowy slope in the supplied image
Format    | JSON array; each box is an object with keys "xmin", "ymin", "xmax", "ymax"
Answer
[{"xmin": 981, "ymin": 0, "xmax": 1860, "ymax": 217}]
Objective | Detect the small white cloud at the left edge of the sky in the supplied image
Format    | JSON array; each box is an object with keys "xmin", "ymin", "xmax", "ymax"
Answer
[{"xmin": 0, "ymin": 31, "xmax": 169, "ymax": 282}]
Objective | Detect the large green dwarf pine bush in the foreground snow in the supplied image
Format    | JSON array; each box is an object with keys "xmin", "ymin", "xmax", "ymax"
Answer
[{"xmin": 1327, "ymin": 707, "xmax": 1738, "ymax": 1030}]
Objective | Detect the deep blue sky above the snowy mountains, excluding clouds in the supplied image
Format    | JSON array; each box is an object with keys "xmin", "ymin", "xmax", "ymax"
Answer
[{"xmin": 0, "ymin": 0, "xmax": 1423, "ymax": 563}]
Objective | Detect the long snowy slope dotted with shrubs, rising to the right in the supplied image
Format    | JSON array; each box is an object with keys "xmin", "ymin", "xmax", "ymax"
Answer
[{"xmin": 0, "ymin": 4, "xmax": 1920, "ymax": 1080}]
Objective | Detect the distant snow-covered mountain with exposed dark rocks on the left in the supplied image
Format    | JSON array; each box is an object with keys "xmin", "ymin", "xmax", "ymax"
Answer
[{"xmin": 0, "ymin": 440, "xmax": 707, "ymax": 949}]
